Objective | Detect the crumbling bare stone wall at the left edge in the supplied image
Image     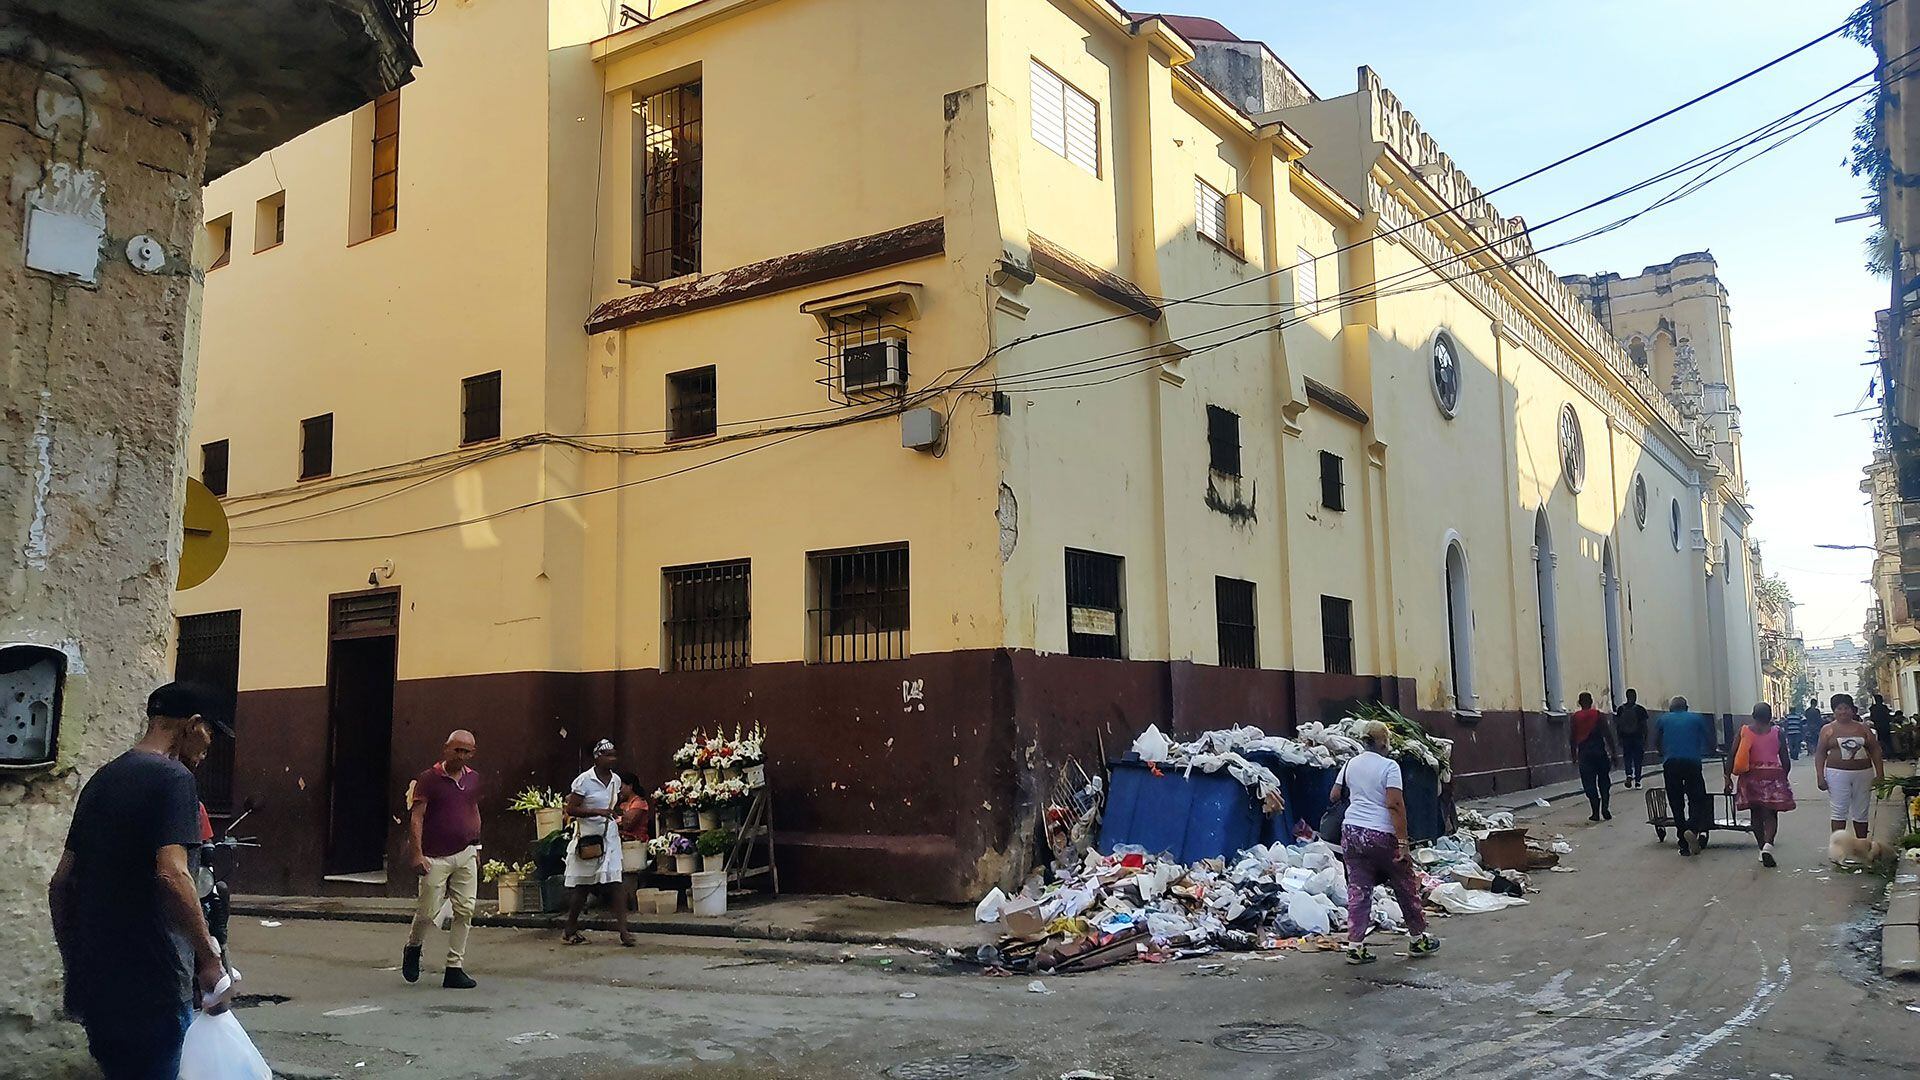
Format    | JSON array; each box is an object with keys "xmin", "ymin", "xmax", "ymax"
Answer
[{"xmin": 0, "ymin": 29, "xmax": 209, "ymax": 1076}]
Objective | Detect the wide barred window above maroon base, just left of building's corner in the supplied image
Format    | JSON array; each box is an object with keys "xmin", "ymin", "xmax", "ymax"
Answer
[{"xmin": 806, "ymin": 544, "xmax": 912, "ymax": 663}]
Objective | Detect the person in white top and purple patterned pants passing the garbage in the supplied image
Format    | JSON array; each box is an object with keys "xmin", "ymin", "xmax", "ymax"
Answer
[{"xmin": 1332, "ymin": 721, "xmax": 1440, "ymax": 965}]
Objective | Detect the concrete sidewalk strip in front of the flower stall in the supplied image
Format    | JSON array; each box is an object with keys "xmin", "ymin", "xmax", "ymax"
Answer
[{"xmin": 232, "ymin": 883, "xmax": 995, "ymax": 953}]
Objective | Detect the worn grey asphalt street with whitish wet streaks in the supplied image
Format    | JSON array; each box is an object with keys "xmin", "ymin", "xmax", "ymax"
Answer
[{"xmin": 220, "ymin": 774, "xmax": 1920, "ymax": 1080}]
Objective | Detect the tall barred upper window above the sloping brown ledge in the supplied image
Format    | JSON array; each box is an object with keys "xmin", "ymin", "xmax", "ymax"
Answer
[{"xmin": 634, "ymin": 83, "xmax": 703, "ymax": 281}]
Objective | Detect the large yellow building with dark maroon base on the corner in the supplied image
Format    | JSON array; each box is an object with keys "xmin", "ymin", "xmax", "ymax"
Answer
[{"xmin": 177, "ymin": 0, "xmax": 1757, "ymax": 899}]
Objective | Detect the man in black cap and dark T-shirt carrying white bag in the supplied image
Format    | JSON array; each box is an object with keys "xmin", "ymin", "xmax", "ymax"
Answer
[{"xmin": 48, "ymin": 682, "xmax": 225, "ymax": 1080}]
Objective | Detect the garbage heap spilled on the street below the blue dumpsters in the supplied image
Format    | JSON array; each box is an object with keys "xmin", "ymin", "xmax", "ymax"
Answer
[{"xmin": 975, "ymin": 811, "xmax": 1532, "ymax": 974}]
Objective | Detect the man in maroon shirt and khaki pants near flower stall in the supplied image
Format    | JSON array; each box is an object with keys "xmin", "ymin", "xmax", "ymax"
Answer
[{"xmin": 399, "ymin": 730, "xmax": 480, "ymax": 990}]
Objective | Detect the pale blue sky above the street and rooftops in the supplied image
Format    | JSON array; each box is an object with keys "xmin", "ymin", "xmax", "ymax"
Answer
[{"xmin": 1169, "ymin": 0, "xmax": 1887, "ymax": 644}]
